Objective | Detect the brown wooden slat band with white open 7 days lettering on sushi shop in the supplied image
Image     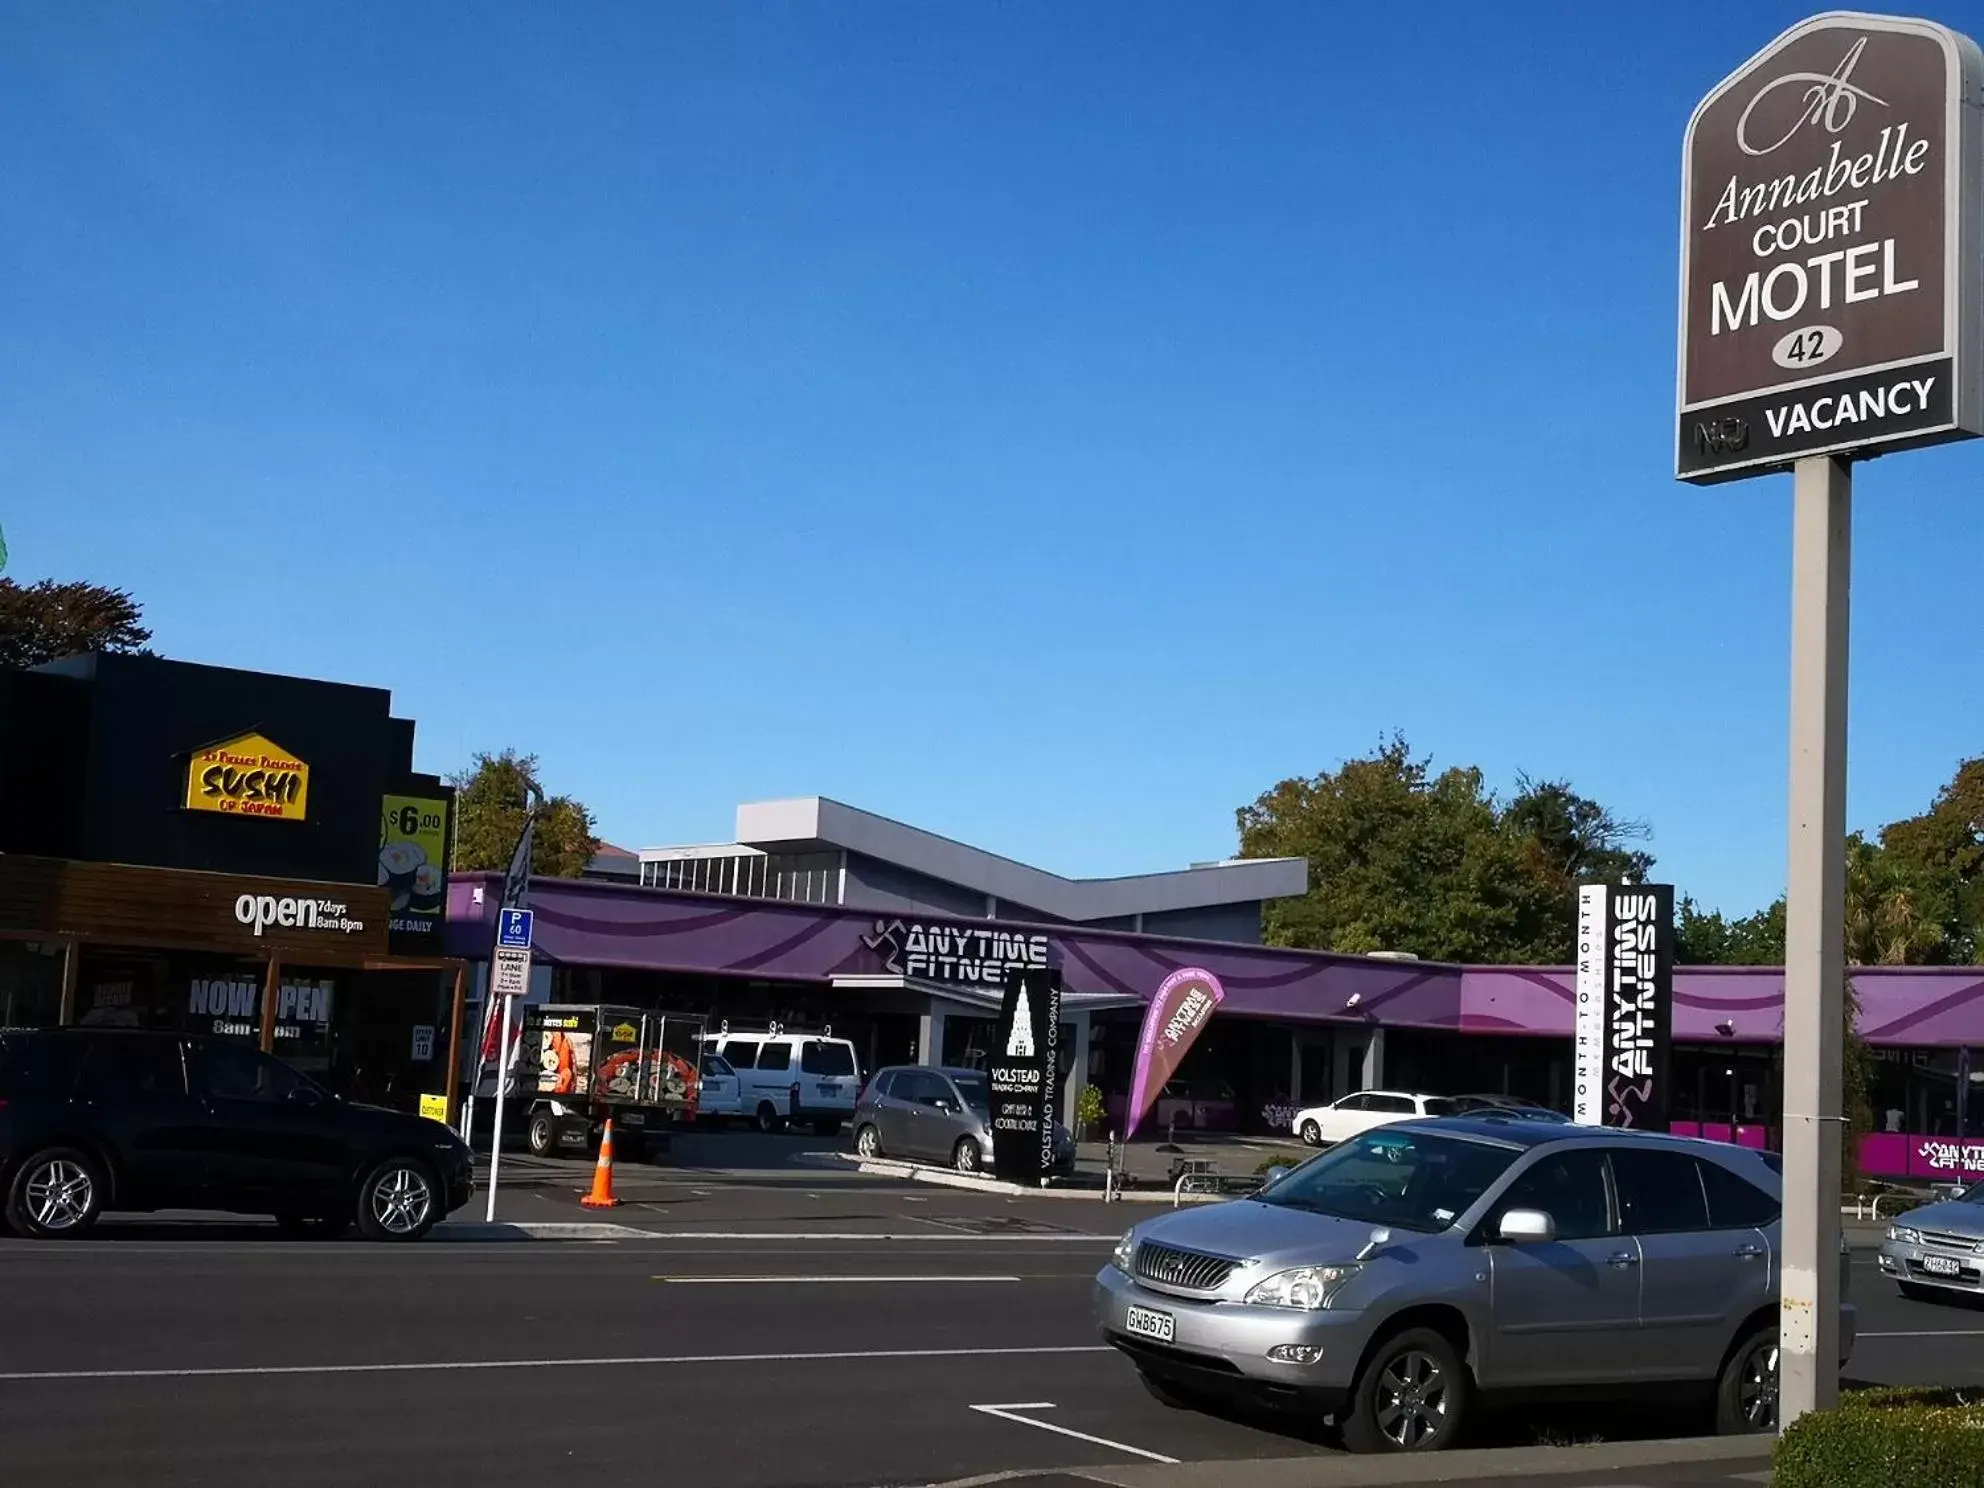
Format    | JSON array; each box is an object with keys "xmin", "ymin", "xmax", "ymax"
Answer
[{"xmin": 0, "ymin": 855, "xmax": 391, "ymax": 962}]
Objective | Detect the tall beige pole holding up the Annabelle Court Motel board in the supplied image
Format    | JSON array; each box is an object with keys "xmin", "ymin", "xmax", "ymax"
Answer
[{"xmin": 1778, "ymin": 456, "xmax": 1853, "ymax": 1428}]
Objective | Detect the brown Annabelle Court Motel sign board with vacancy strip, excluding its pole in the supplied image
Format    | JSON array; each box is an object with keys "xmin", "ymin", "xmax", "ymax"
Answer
[{"xmin": 1674, "ymin": 12, "xmax": 1984, "ymax": 484}]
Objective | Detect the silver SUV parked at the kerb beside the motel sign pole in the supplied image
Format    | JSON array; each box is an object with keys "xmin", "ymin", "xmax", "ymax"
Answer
[{"xmin": 1095, "ymin": 1117, "xmax": 1855, "ymax": 1452}]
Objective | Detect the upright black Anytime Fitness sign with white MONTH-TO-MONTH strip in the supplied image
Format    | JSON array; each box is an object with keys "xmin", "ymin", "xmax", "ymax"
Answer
[{"xmin": 1571, "ymin": 883, "xmax": 1674, "ymax": 1131}]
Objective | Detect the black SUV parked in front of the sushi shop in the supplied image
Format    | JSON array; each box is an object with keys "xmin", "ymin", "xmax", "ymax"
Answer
[{"xmin": 0, "ymin": 1028, "xmax": 474, "ymax": 1240}]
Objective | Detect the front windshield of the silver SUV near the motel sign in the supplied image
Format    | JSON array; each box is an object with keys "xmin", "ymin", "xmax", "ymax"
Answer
[{"xmin": 1260, "ymin": 1127, "xmax": 1522, "ymax": 1234}]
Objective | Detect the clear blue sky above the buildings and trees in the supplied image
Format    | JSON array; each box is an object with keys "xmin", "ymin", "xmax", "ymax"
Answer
[{"xmin": 0, "ymin": 0, "xmax": 1984, "ymax": 911}]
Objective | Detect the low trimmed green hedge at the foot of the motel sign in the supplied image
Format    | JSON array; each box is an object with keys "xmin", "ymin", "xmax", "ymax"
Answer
[{"xmin": 1770, "ymin": 1389, "xmax": 1984, "ymax": 1488}]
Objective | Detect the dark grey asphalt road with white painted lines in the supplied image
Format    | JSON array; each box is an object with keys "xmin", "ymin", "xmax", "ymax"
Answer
[{"xmin": 11, "ymin": 1165, "xmax": 1984, "ymax": 1488}]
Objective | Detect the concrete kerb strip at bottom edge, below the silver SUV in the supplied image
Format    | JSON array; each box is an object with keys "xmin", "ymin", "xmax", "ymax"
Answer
[{"xmin": 942, "ymin": 1436, "xmax": 1778, "ymax": 1488}]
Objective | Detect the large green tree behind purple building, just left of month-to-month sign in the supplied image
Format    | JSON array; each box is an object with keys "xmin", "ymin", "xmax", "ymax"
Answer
[{"xmin": 1236, "ymin": 734, "xmax": 1575, "ymax": 962}]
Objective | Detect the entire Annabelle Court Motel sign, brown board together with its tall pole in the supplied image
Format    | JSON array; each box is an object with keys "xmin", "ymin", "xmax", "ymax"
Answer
[{"xmin": 1674, "ymin": 12, "xmax": 1984, "ymax": 1428}]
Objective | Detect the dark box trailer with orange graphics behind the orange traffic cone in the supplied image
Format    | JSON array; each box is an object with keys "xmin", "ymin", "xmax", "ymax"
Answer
[{"xmin": 503, "ymin": 1002, "xmax": 704, "ymax": 1163}]
